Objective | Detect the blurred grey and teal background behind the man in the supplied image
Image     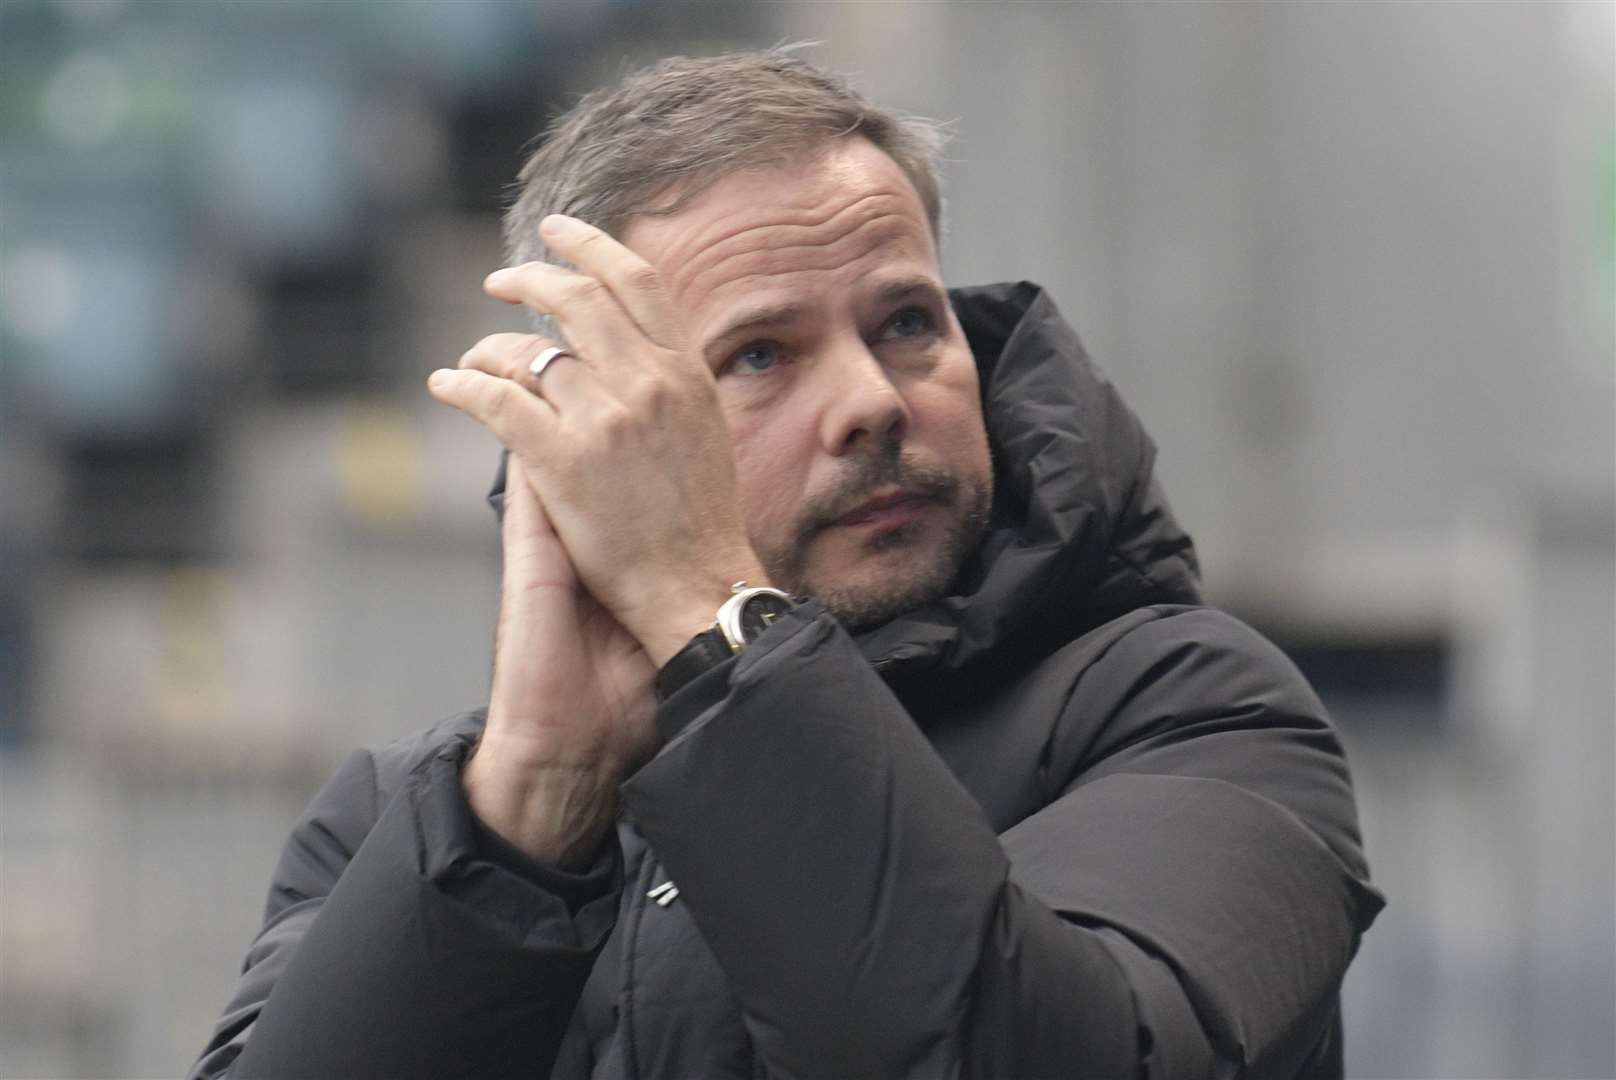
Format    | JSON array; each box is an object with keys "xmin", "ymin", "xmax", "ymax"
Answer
[{"xmin": 0, "ymin": 0, "xmax": 1616, "ymax": 1078}]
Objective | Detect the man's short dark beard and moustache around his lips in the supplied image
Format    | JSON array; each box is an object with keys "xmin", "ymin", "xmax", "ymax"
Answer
[{"xmin": 760, "ymin": 441, "xmax": 994, "ymax": 632}]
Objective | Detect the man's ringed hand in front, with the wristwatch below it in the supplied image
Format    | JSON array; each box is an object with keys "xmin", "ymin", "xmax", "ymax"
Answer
[{"xmin": 428, "ymin": 215, "xmax": 768, "ymax": 666}]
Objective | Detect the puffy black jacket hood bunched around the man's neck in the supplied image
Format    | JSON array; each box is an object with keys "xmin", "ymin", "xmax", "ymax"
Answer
[{"xmin": 861, "ymin": 281, "xmax": 1201, "ymax": 669}]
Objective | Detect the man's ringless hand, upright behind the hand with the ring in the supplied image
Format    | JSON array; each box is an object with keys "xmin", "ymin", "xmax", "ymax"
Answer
[{"xmin": 462, "ymin": 454, "xmax": 656, "ymax": 867}]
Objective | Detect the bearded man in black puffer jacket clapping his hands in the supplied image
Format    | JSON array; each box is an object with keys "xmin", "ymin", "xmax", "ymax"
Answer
[{"xmin": 196, "ymin": 52, "xmax": 1380, "ymax": 1078}]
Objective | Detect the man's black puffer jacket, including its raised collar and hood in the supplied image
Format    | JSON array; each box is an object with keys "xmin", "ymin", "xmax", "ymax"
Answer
[{"xmin": 196, "ymin": 285, "xmax": 1380, "ymax": 1078}]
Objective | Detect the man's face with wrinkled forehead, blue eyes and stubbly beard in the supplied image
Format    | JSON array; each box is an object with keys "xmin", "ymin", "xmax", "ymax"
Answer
[{"xmin": 622, "ymin": 139, "xmax": 992, "ymax": 627}]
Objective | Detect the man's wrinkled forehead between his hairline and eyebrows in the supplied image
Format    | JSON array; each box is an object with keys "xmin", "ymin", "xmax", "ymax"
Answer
[{"xmin": 622, "ymin": 139, "xmax": 937, "ymax": 340}]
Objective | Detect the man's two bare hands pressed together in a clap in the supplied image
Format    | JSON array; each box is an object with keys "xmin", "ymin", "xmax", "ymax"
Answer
[{"xmin": 428, "ymin": 215, "xmax": 764, "ymax": 863}]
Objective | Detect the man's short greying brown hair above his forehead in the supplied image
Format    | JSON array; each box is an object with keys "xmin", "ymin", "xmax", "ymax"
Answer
[{"xmin": 504, "ymin": 47, "xmax": 945, "ymax": 271}]
